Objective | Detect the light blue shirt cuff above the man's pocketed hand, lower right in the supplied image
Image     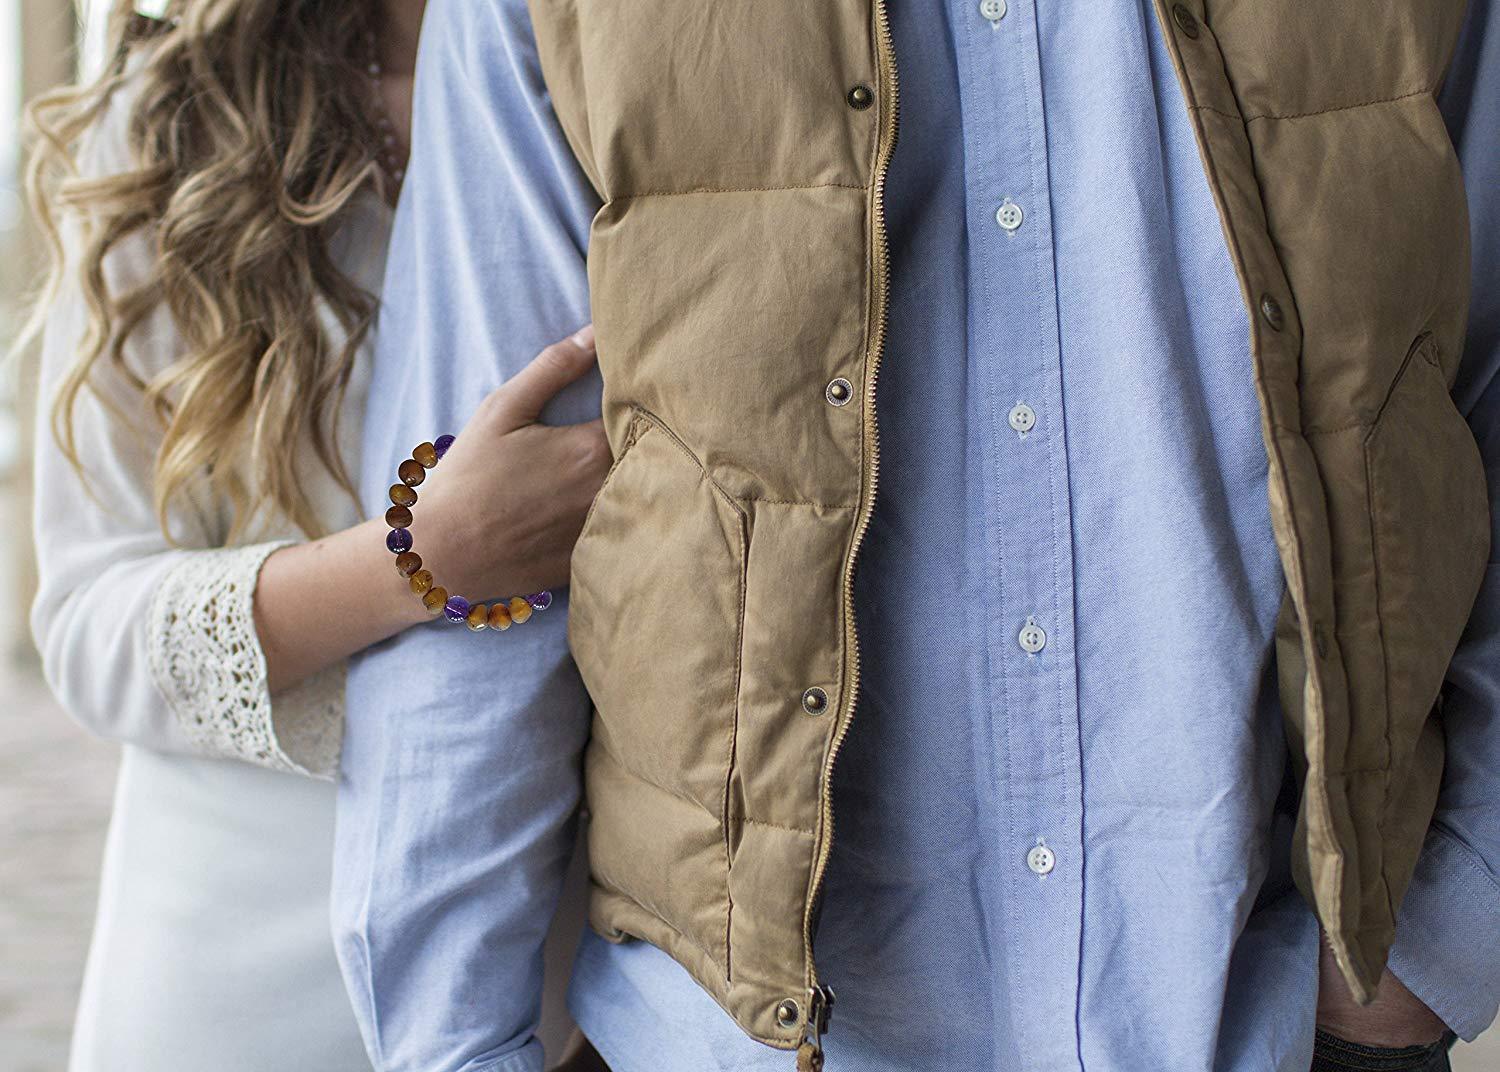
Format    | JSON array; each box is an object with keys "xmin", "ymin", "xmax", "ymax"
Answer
[{"xmin": 1391, "ymin": 826, "xmax": 1500, "ymax": 1042}]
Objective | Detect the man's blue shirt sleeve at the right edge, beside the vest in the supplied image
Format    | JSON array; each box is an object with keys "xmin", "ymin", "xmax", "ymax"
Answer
[{"xmin": 1391, "ymin": 0, "xmax": 1500, "ymax": 1041}]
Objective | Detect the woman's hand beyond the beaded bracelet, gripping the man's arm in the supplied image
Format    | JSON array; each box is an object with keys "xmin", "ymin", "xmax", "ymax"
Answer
[{"xmin": 411, "ymin": 325, "xmax": 611, "ymax": 600}]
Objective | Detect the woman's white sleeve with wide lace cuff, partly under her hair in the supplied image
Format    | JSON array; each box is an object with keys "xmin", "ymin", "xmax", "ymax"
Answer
[{"xmin": 32, "ymin": 81, "xmax": 342, "ymax": 777}]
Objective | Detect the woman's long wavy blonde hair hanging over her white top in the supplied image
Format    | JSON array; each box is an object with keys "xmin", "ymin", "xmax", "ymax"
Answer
[{"xmin": 27, "ymin": 0, "xmax": 386, "ymax": 541}]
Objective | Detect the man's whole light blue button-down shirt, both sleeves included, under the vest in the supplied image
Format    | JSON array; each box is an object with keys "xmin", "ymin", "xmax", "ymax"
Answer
[{"xmin": 335, "ymin": 0, "xmax": 1500, "ymax": 1072}]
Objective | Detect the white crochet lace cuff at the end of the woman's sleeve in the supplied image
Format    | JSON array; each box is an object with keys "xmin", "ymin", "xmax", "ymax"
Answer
[{"xmin": 147, "ymin": 543, "xmax": 344, "ymax": 778}]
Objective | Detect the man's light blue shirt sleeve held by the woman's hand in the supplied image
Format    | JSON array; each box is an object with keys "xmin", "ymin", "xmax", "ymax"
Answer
[{"xmin": 332, "ymin": 0, "xmax": 600, "ymax": 1072}]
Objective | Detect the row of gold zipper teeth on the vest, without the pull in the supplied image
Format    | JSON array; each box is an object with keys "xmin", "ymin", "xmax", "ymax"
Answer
[{"xmin": 803, "ymin": 0, "xmax": 900, "ymax": 1025}]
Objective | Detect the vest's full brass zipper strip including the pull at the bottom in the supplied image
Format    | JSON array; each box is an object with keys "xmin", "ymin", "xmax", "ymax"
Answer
[{"xmin": 797, "ymin": 0, "xmax": 900, "ymax": 1072}]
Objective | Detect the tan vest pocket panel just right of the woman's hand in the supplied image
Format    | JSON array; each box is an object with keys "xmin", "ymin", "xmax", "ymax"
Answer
[{"xmin": 569, "ymin": 411, "xmax": 749, "ymax": 964}]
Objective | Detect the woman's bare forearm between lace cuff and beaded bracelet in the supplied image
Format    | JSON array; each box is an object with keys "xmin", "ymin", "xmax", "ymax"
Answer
[{"xmin": 255, "ymin": 519, "xmax": 428, "ymax": 694}]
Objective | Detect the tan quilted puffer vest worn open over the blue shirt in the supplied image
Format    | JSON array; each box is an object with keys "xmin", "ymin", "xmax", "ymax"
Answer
[{"xmin": 531, "ymin": 0, "xmax": 1490, "ymax": 1063}]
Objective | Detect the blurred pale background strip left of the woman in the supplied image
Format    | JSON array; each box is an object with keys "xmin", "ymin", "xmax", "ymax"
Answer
[{"xmin": 0, "ymin": 0, "xmax": 127, "ymax": 1072}]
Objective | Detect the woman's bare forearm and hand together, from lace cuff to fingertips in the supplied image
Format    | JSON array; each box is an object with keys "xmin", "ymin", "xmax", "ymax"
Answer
[{"xmin": 255, "ymin": 328, "xmax": 609, "ymax": 693}]
